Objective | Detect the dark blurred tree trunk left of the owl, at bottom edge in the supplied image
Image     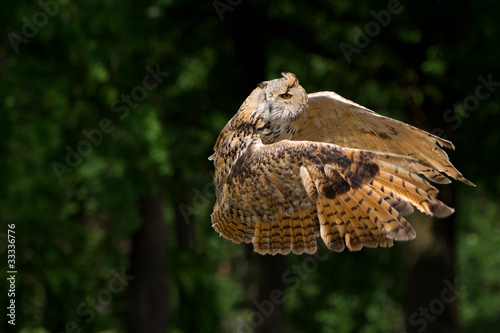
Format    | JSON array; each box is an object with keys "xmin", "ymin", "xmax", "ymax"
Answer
[{"xmin": 127, "ymin": 195, "xmax": 167, "ymax": 333}]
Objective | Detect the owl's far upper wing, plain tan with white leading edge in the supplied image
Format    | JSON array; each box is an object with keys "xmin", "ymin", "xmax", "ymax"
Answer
[{"xmin": 292, "ymin": 92, "xmax": 475, "ymax": 186}]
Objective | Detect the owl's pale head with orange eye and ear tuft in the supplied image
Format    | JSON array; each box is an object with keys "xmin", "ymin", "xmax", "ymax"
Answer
[{"xmin": 255, "ymin": 72, "xmax": 308, "ymax": 124}]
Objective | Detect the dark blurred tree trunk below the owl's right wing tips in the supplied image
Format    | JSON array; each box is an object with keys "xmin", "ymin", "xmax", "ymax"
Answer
[{"xmin": 405, "ymin": 208, "xmax": 461, "ymax": 333}]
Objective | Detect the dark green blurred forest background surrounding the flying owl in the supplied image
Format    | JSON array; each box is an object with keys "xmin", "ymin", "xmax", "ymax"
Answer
[{"xmin": 0, "ymin": 0, "xmax": 500, "ymax": 333}]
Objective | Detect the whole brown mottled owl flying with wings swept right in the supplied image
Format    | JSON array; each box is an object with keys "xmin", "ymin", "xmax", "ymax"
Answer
[{"xmin": 209, "ymin": 72, "xmax": 475, "ymax": 255}]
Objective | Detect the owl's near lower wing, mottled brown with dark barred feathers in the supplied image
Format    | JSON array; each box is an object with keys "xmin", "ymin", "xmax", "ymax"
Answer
[{"xmin": 211, "ymin": 140, "xmax": 453, "ymax": 255}]
